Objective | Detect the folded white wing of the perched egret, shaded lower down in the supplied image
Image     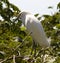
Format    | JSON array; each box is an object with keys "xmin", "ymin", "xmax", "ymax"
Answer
[{"xmin": 26, "ymin": 17, "xmax": 49, "ymax": 47}]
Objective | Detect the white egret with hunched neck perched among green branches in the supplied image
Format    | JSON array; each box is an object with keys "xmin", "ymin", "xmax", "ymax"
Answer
[{"xmin": 16, "ymin": 12, "xmax": 50, "ymax": 48}]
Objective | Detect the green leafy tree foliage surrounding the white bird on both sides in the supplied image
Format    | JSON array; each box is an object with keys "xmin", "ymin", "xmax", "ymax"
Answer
[{"xmin": 0, "ymin": 0, "xmax": 60, "ymax": 63}]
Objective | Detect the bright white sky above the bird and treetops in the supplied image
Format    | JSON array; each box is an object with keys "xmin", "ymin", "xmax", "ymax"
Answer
[{"xmin": 9, "ymin": 0, "xmax": 60, "ymax": 15}]
